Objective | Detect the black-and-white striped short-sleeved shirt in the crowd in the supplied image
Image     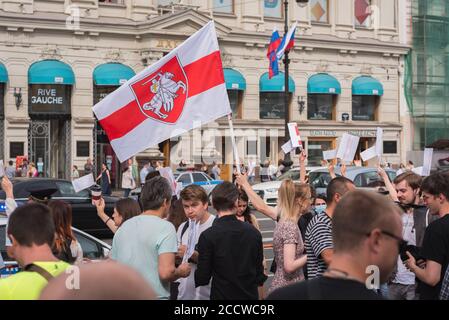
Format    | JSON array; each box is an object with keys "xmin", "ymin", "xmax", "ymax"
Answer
[{"xmin": 305, "ymin": 213, "xmax": 333, "ymax": 279}]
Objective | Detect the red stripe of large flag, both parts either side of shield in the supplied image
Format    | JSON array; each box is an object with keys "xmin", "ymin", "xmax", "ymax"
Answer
[{"xmin": 100, "ymin": 51, "xmax": 224, "ymax": 141}]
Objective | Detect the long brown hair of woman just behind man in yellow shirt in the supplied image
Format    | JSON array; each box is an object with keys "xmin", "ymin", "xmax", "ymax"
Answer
[{"xmin": 48, "ymin": 200, "xmax": 76, "ymax": 252}]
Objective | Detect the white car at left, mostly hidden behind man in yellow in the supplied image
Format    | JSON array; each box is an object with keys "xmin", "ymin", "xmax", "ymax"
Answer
[{"xmin": 0, "ymin": 215, "xmax": 111, "ymax": 278}]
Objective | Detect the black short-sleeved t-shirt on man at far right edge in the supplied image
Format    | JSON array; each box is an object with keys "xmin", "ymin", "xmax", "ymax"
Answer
[{"xmin": 420, "ymin": 214, "xmax": 449, "ymax": 300}]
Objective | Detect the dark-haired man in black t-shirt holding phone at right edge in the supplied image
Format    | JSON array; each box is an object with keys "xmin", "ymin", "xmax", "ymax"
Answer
[{"xmin": 405, "ymin": 173, "xmax": 449, "ymax": 300}]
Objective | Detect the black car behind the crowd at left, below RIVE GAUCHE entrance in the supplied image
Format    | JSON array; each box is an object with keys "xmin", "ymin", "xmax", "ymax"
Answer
[{"xmin": 0, "ymin": 178, "xmax": 119, "ymax": 239}]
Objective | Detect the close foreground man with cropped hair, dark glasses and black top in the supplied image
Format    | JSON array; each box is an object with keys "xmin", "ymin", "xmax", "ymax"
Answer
[{"xmin": 267, "ymin": 190, "xmax": 404, "ymax": 300}]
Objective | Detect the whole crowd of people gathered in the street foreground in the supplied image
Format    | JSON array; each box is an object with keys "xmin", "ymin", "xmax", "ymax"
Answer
[{"xmin": 0, "ymin": 153, "xmax": 449, "ymax": 300}]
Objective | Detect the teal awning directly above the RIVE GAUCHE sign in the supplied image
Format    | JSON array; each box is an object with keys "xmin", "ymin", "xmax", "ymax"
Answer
[{"xmin": 28, "ymin": 60, "xmax": 75, "ymax": 85}]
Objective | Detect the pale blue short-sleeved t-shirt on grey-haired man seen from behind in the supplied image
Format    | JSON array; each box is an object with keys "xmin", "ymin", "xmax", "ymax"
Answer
[{"xmin": 111, "ymin": 215, "xmax": 178, "ymax": 299}]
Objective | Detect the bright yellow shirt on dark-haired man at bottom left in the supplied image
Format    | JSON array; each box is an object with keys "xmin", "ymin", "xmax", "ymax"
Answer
[{"xmin": 0, "ymin": 261, "xmax": 70, "ymax": 301}]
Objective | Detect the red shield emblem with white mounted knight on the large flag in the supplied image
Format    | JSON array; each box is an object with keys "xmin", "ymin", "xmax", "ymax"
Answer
[{"xmin": 130, "ymin": 55, "xmax": 188, "ymax": 124}]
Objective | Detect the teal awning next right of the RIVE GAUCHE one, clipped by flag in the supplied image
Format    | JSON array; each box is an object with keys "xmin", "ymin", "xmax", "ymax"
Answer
[{"xmin": 93, "ymin": 63, "xmax": 136, "ymax": 86}]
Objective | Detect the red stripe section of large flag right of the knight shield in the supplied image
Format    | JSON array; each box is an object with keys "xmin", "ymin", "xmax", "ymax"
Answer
[{"xmin": 184, "ymin": 51, "xmax": 224, "ymax": 98}]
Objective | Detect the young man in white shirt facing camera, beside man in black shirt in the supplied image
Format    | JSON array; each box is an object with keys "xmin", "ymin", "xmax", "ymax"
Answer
[{"xmin": 177, "ymin": 184, "xmax": 215, "ymax": 300}]
